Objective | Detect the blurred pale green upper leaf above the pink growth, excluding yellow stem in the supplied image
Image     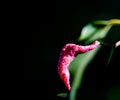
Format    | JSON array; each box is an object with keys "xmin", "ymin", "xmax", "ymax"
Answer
[{"xmin": 78, "ymin": 21, "xmax": 112, "ymax": 43}]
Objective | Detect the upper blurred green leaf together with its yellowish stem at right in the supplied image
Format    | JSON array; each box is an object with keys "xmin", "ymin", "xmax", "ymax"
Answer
[{"xmin": 78, "ymin": 19, "xmax": 120, "ymax": 42}]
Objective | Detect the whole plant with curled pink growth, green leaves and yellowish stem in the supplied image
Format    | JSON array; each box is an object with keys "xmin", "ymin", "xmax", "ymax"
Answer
[{"xmin": 57, "ymin": 19, "xmax": 120, "ymax": 100}]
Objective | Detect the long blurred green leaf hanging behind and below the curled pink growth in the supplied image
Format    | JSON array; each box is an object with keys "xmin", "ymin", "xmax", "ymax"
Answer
[{"xmin": 69, "ymin": 46, "xmax": 101, "ymax": 100}]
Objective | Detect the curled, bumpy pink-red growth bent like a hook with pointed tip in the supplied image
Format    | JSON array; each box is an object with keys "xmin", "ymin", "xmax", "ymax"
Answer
[{"xmin": 58, "ymin": 41, "xmax": 100, "ymax": 91}]
